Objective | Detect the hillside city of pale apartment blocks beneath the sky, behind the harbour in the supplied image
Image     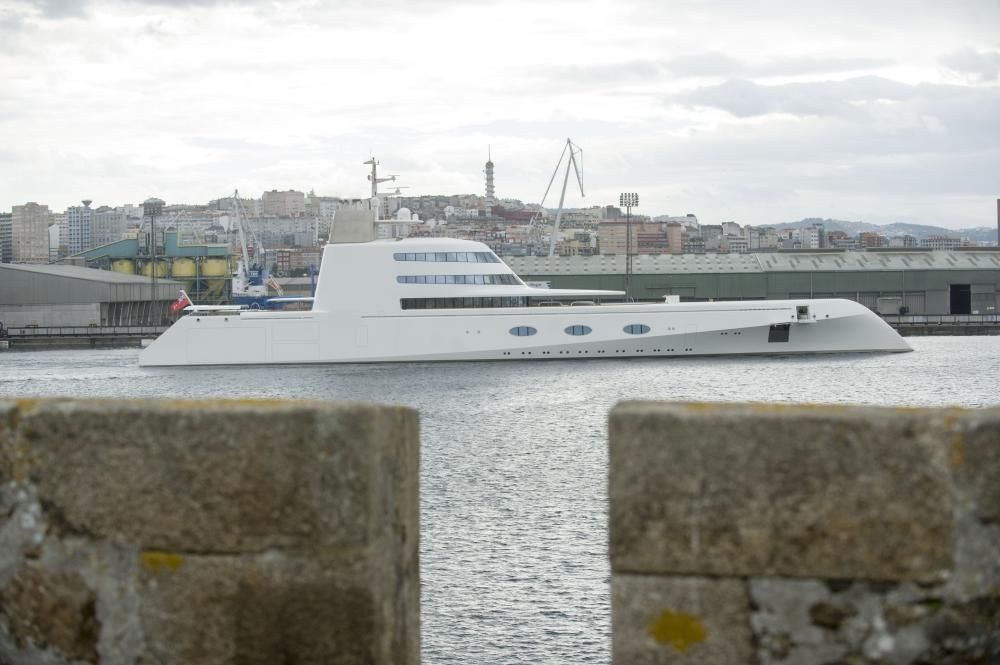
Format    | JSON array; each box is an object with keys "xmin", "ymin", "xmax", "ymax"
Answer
[{"xmin": 0, "ymin": 184, "xmax": 992, "ymax": 274}]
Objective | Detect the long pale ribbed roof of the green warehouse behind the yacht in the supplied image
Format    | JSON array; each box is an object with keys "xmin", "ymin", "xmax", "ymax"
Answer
[{"xmin": 502, "ymin": 250, "xmax": 1000, "ymax": 275}]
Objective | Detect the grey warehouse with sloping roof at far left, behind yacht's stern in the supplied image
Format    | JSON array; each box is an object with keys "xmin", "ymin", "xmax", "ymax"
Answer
[{"xmin": 0, "ymin": 263, "xmax": 181, "ymax": 328}]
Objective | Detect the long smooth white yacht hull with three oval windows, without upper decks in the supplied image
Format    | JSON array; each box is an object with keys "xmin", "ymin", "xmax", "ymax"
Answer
[{"xmin": 139, "ymin": 300, "xmax": 912, "ymax": 367}]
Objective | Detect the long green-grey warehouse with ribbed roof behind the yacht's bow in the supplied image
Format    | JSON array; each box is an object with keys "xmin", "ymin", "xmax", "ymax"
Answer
[{"xmin": 504, "ymin": 247, "xmax": 1000, "ymax": 315}]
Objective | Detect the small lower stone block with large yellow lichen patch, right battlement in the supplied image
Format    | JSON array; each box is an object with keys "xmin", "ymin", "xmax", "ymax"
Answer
[{"xmin": 611, "ymin": 573, "xmax": 754, "ymax": 665}]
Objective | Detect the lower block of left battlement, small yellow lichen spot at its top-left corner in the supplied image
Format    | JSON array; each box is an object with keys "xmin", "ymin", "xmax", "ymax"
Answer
[{"xmin": 139, "ymin": 552, "xmax": 400, "ymax": 665}]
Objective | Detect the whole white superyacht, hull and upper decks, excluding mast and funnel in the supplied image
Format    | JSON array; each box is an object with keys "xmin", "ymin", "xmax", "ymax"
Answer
[{"xmin": 139, "ymin": 238, "xmax": 911, "ymax": 366}]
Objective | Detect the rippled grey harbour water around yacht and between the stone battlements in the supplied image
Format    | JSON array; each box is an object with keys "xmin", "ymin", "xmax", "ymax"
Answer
[{"xmin": 0, "ymin": 337, "xmax": 1000, "ymax": 665}]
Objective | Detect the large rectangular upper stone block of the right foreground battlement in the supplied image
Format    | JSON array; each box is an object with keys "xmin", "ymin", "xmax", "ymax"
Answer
[{"xmin": 609, "ymin": 402, "xmax": 953, "ymax": 581}]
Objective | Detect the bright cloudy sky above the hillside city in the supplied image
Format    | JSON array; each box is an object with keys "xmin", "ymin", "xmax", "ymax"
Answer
[{"xmin": 0, "ymin": 0, "xmax": 1000, "ymax": 228}]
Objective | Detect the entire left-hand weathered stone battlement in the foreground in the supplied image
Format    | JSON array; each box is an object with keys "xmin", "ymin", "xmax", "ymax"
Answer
[{"xmin": 0, "ymin": 400, "xmax": 420, "ymax": 665}]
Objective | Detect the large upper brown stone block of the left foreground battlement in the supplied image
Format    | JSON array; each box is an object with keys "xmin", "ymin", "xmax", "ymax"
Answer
[{"xmin": 18, "ymin": 401, "xmax": 418, "ymax": 553}]
